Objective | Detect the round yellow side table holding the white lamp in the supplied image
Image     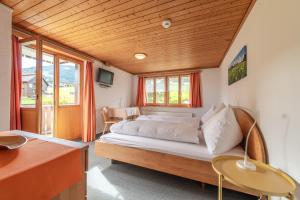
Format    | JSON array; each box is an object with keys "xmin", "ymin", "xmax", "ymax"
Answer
[{"xmin": 212, "ymin": 156, "xmax": 296, "ymax": 200}]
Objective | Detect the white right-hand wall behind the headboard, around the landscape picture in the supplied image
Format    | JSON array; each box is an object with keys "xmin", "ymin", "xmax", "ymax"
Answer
[{"xmin": 221, "ymin": 0, "xmax": 300, "ymax": 197}]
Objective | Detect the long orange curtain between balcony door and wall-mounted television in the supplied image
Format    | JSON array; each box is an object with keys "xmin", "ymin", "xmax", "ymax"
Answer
[{"xmin": 82, "ymin": 62, "xmax": 96, "ymax": 142}]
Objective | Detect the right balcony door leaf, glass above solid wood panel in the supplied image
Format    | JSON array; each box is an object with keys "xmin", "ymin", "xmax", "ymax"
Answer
[{"xmin": 55, "ymin": 55, "xmax": 83, "ymax": 139}]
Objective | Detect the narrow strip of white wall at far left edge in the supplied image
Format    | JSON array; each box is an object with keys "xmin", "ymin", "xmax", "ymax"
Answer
[{"xmin": 0, "ymin": 3, "xmax": 12, "ymax": 131}]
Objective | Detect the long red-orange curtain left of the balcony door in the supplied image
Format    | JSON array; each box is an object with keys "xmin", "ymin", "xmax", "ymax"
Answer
[{"xmin": 10, "ymin": 36, "xmax": 22, "ymax": 130}]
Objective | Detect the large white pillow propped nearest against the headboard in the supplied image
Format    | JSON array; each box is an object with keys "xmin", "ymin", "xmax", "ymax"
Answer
[{"xmin": 202, "ymin": 107, "xmax": 243, "ymax": 154}]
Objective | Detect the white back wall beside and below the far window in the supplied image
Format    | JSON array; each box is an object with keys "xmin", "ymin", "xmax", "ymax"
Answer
[{"xmin": 132, "ymin": 68, "xmax": 220, "ymax": 116}]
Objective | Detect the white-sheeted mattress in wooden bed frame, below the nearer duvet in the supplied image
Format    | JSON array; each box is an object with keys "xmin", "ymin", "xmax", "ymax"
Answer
[{"xmin": 99, "ymin": 133, "xmax": 244, "ymax": 161}]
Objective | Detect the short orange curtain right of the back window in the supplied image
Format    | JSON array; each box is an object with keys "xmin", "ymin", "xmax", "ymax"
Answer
[{"xmin": 190, "ymin": 72, "xmax": 202, "ymax": 108}]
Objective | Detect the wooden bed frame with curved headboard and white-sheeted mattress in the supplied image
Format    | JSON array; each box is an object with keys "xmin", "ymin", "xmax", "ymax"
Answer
[{"xmin": 95, "ymin": 108, "xmax": 268, "ymax": 195}]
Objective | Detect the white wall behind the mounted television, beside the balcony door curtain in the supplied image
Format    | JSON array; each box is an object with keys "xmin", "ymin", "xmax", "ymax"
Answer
[{"xmin": 94, "ymin": 62, "xmax": 133, "ymax": 133}]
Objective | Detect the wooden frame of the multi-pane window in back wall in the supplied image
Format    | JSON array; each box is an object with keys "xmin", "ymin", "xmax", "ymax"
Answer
[{"xmin": 144, "ymin": 73, "xmax": 191, "ymax": 108}]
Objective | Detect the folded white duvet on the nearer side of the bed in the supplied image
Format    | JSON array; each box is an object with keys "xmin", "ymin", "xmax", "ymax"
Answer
[{"xmin": 110, "ymin": 119, "xmax": 199, "ymax": 144}]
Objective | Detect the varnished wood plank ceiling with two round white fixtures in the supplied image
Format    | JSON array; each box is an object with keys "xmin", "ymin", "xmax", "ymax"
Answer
[{"xmin": 0, "ymin": 0, "xmax": 252, "ymax": 73}]
